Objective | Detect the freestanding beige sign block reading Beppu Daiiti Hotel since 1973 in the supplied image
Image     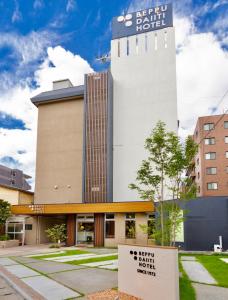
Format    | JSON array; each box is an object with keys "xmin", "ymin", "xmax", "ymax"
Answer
[{"xmin": 118, "ymin": 245, "xmax": 179, "ymax": 300}]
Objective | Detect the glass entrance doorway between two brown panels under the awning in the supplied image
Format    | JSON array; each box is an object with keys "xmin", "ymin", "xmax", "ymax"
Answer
[{"xmin": 76, "ymin": 214, "xmax": 94, "ymax": 245}]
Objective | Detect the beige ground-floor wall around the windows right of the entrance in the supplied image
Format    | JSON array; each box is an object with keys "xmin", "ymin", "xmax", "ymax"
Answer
[{"xmin": 105, "ymin": 213, "xmax": 148, "ymax": 247}]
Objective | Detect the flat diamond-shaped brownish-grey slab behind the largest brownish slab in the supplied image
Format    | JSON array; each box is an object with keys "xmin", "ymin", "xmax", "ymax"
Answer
[{"xmin": 26, "ymin": 261, "xmax": 84, "ymax": 274}]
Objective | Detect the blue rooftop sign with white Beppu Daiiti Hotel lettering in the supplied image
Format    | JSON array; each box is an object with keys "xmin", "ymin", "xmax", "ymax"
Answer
[{"xmin": 112, "ymin": 4, "xmax": 173, "ymax": 40}]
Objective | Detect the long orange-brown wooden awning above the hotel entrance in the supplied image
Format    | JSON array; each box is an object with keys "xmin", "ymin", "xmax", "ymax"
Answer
[{"xmin": 11, "ymin": 201, "xmax": 154, "ymax": 215}]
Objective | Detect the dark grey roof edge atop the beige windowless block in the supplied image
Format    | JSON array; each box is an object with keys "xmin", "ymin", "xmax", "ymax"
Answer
[{"xmin": 31, "ymin": 85, "xmax": 84, "ymax": 106}]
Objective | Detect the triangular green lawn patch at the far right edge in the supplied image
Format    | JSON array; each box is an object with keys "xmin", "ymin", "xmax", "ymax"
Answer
[{"xmin": 195, "ymin": 254, "xmax": 228, "ymax": 288}]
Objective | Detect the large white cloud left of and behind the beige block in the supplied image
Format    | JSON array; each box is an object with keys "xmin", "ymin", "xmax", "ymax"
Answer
[{"xmin": 0, "ymin": 46, "xmax": 93, "ymax": 189}]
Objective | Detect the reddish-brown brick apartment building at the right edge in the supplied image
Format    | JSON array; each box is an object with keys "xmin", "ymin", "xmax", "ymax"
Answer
[{"xmin": 192, "ymin": 114, "xmax": 228, "ymax": 197}]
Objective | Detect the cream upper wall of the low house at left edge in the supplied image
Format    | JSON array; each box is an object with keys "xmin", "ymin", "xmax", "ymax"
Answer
[{"xmin": 0, "ymin": 186, "xmax": 33, "ymax": 205}]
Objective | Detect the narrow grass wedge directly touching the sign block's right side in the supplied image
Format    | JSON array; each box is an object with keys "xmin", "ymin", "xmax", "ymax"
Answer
[{"xmin": 179, "ymin": 261, "xmax": 196, "ymax": 300}]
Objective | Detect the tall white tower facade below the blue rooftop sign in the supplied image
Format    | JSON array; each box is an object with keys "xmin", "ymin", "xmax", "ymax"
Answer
[{"xmin": 111, "ymin": 27, "xmax": 177, "ymax": 202}]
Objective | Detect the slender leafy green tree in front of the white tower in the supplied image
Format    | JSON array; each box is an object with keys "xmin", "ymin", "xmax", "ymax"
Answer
[{"xmin": 129, "ymin": 121, "xmax": 197, "ymax": 245}]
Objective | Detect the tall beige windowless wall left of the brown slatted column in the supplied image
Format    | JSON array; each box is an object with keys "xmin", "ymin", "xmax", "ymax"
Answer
[{"xmin": 34, "ymin": 99, "xmax": 83, "ymax": 204}]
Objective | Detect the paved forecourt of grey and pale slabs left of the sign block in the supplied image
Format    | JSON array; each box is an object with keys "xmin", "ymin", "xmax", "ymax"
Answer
[{"xmin": 0, "ymin": 248, "xmax": 118, "ymax": 300}]
